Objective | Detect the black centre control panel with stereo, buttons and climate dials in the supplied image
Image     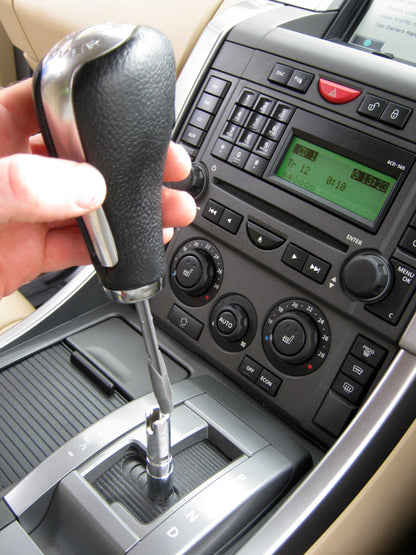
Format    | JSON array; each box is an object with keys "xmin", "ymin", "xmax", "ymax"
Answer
[{"xmin": 153, "ymin": 0, "xmax": 416, "ymax": 446}]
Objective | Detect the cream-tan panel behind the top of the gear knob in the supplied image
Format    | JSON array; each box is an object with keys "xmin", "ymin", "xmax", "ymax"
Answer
[{"xmin": 0, "ymin": 0, "xmax": 232, "ymax": 71}]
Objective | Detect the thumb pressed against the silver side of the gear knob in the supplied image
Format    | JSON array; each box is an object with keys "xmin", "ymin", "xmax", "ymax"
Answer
[{"xmin": 0, "ymin": 154, "xmax": 106, "ymax": 223}]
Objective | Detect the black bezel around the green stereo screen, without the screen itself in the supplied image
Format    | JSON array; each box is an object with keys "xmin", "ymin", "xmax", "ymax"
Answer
[{"xmin": 267, "ymin": 110, "xmax": 414, "ymax": 233}]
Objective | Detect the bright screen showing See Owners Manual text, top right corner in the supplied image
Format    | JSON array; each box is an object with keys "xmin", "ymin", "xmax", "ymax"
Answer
[{"xmin": 349, "ymin": 0, "xmax": 416, "ymax": 63}]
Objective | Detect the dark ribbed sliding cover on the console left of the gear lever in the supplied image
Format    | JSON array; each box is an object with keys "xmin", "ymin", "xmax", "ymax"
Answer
[{"xmin": 0, "ymin": 343, "xmax": 127, "ymax": 491}]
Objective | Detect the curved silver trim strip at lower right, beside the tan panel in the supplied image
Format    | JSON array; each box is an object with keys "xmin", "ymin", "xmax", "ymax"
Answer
[{"xmin": 237, "ymin": 350, "xmax": 416, "ymax": 555}]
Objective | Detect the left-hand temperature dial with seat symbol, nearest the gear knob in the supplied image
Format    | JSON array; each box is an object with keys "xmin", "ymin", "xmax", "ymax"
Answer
[{"xmin": 170, "ymin": 239, "xmax": 224, "ymax": 306}]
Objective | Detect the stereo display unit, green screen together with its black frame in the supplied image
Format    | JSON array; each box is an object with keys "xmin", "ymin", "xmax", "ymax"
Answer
[{"xmin": 267, "ymin": 110, "xmax": 414, "ymax": 232}]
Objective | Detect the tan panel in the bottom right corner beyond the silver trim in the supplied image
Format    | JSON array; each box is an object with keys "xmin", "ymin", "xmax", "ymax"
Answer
[{"xmin": 307, "ymin": 422, "xmax": 416, "ymax": 555}]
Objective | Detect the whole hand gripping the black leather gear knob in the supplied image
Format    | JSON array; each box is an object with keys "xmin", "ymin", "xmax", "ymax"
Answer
[{"xmin": 0, "ymin": 80, "xmax": 195, "ymax": 298}]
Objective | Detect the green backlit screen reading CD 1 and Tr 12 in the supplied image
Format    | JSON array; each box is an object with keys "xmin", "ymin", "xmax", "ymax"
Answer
[{"xmin": 276, "ymin": 137, "xmax": 396, "ymax": 222}]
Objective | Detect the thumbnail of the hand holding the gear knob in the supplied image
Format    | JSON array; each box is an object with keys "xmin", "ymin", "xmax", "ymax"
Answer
[{"xmin": 73, "ymin": 164, "xmax": 106, "ymax": 210}]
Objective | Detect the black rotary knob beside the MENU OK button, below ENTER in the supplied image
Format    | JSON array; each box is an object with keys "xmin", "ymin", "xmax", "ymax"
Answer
[{"xmin": 342, "ymin": 253, "xmax": 393, "ymax": 303}]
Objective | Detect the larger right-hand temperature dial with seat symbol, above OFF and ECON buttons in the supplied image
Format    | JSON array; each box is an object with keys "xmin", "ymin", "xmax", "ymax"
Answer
[{"xmin": 263, "ymin": 299, "xmax": 330, "ymax": 376}]
